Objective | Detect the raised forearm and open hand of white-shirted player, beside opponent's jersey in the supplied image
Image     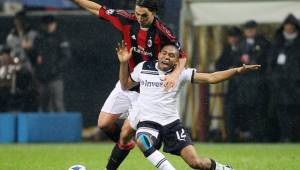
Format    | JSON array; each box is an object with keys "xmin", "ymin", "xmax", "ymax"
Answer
[{"xmin": 116, "ymin": 40, "xmax": 135, "ymax": 90}]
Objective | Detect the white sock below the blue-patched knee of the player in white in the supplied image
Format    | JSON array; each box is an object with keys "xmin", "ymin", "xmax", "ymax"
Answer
[{"xmin": 147, "ymin": 150, "xmax": 176, "ymax": 170}]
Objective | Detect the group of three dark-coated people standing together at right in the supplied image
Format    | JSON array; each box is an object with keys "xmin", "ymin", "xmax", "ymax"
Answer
[{"xmin": 216, "ymin": 14, "xmax": 300, "ymax": 142}]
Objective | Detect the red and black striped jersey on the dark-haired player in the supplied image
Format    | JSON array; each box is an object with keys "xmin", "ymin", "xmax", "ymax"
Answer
[{"xmin": 99, "ymin": 7, "xmax": 186, "ymax": 72}]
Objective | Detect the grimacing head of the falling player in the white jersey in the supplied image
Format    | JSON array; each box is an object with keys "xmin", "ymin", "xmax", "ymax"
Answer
[{"xmin": 158, "ymin": 45, "xmax": 178, "ymax": 71}]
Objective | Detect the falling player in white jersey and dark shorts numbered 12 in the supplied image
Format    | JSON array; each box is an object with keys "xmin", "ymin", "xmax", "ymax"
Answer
[{"xmin": 116, "ymin": 42, "xmax": 260, "ymax": 170}]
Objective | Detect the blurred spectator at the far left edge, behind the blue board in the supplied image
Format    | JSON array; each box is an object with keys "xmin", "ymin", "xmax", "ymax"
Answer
[{"xmin": 0, "ymin": 46, "xmax": 37, "ymax": 112}]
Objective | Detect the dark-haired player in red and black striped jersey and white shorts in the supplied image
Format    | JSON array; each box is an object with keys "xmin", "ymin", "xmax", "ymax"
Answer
[{"xmin": 73, "ymin": 0, "xmax": 186, "ymax": 170}]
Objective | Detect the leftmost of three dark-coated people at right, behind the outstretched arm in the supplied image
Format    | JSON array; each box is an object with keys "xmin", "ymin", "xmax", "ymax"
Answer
[{"xmin": 216, "ymin": 27, "xmax": 242, "ymax": 142}]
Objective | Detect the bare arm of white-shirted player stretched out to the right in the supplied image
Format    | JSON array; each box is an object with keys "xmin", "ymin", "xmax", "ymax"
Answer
[{"xmin": 194, "ymin": 65, "xmax": 261, "ymax": 84}]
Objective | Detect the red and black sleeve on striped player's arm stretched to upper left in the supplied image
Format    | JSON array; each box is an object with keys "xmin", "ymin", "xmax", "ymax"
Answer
[{"xmin": 99, "ymin": 7, "xmax": 135, "ymax": 31}]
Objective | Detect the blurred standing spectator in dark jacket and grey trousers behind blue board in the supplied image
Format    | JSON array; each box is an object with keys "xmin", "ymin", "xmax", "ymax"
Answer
[{"xmin": 34, "ymin": 15, "xmax": 71, "ymax": 112}]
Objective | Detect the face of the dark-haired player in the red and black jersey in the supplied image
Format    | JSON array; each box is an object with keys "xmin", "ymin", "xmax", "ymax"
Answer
[{"xmin": 135, "ymin": 6, "xmax": 155, "ymax": 28}]
